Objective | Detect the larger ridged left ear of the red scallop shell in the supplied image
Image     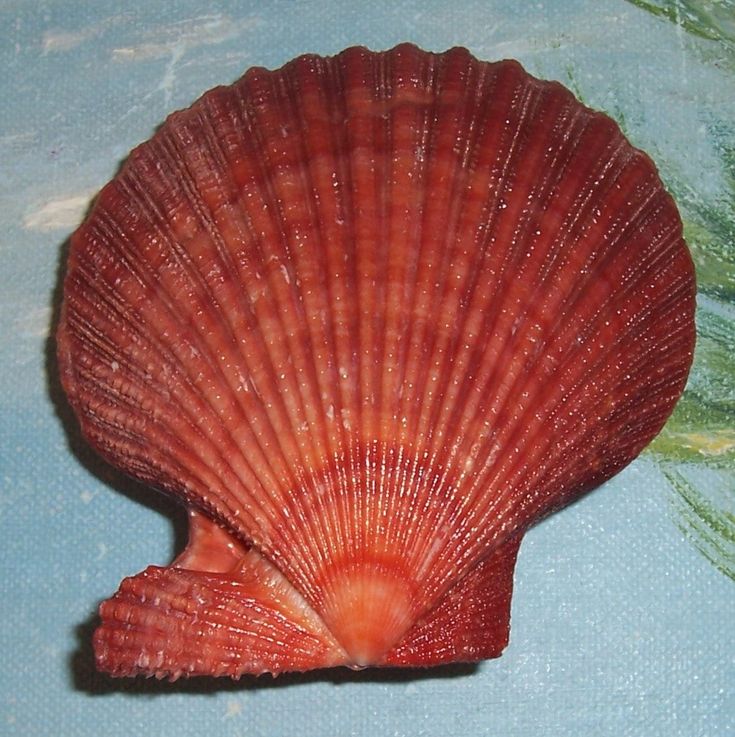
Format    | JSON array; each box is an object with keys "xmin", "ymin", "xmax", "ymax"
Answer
[{"xmin": 94, "ymin": 512, "xmax": 347, "ymax": 680}]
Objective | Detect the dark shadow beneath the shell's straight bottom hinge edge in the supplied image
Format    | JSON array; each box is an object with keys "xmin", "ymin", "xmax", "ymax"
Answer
[{"xmin": 69, "ymin": 614, "xmax": 480, "ymax": 697}]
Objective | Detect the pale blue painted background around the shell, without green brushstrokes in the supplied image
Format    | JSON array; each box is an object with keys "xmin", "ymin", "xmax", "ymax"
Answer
[{"xmin": 0, "ymin": 0, "xmax": 735, "ymax": 737}]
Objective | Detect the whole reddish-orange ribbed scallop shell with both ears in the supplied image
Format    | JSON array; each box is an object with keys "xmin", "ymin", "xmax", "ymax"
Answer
[{"xmin": 58, "ymin": 45, "xmax": 695, "ymax": 678}]
